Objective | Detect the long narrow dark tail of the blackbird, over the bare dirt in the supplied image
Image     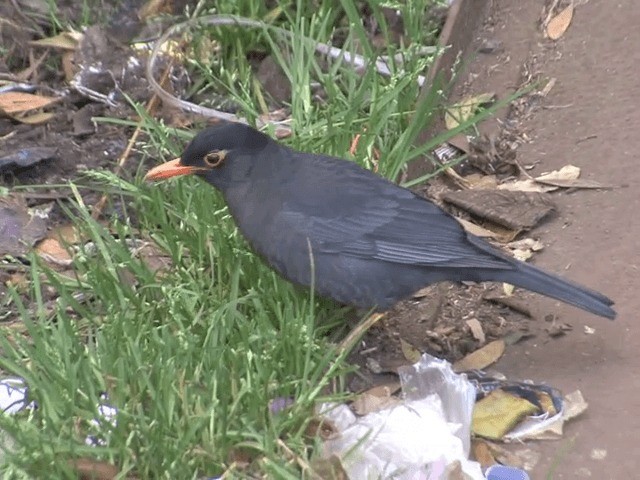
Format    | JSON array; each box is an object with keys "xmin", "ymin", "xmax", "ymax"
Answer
[{"xmin": 495, "ymin": 262, "xmax": 616, "ymax": 320}]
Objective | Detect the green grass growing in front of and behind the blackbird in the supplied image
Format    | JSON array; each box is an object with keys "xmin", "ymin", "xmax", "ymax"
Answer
[{"xmin": 0, "ymin": 0, "xmax": 490, "ymax": 479}]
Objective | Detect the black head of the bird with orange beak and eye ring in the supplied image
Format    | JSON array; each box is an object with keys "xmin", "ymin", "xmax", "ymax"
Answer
[{"xmin": 144, "ymin": 123, "xmax": 272, "ymax": 188}]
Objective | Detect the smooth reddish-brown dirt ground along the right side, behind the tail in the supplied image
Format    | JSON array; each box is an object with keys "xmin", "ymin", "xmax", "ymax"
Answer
[{"xmin": 464, "ymin": 0, "xmax": 640, "ymax": 479}]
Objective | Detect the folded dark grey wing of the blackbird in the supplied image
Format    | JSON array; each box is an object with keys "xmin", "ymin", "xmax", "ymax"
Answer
[{"xmin": 280, "ymin": 189, "xmax": 511, "ymax": 268}]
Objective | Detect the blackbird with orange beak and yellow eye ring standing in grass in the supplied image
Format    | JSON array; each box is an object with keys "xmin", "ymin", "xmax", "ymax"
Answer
[{"xmin": 145, "ymin": 123, "xmax": 616, "ymax": 319}]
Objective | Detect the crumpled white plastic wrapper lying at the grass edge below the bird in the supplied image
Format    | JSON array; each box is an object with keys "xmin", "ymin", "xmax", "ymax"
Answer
[{"xmin": 321, "ymin": 354, "xmax": 485, "ymax": 480}]
